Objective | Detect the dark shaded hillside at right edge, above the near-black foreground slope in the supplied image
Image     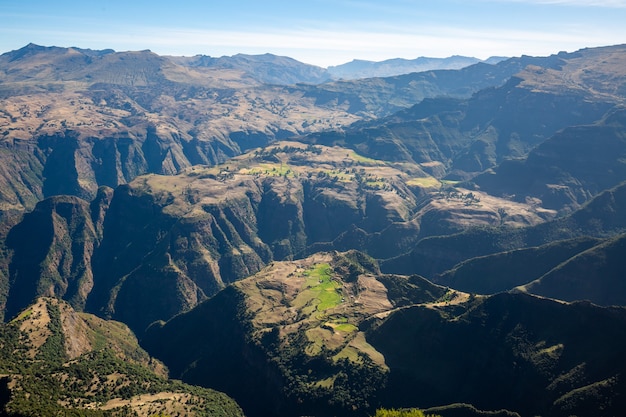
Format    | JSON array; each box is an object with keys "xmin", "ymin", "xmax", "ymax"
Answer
[{"xmin": 433, "ymin": 226, "xmax": 626, "ymax": 306}]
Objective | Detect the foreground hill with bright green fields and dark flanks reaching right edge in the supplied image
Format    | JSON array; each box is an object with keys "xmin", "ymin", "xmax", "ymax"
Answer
[{"xmin": 143, "ymin": 254, "xmax": 626, "ymax": 416}]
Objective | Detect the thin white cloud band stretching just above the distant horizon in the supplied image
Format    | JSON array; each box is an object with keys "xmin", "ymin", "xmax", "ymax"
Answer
[{"xmin": 25, "ymin": 27, "xmax": 613, "ymax": 67}]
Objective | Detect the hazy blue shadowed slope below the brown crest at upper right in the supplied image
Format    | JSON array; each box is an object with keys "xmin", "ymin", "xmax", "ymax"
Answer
[{"xmin": 306, "ymin": 78, "xmax": 615, "ymax": 180}]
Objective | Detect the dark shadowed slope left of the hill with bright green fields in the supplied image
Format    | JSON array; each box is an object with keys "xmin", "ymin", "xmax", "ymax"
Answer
[{"xmin": 142, "ymin": 286, "xmax": 268, "ymax": 415}]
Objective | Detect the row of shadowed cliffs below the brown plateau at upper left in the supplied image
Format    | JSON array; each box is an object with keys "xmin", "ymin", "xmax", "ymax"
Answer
[{"xmin": 32, "ymin": 124, "xmax": 241, "ymax": 202}]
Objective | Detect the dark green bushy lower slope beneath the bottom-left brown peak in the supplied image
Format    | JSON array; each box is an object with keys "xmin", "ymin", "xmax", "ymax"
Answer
[{"xmin": 7, "ymin": 349, "xmax": 236, "ymax": 416}]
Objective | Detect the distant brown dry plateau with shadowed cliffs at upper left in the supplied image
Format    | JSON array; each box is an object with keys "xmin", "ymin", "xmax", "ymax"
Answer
[{"xmin": 0, "ymin": 45, "xmax": 361, "ymax": 209}]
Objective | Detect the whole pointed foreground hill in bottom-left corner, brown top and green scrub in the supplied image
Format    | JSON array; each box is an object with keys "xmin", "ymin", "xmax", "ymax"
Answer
[{"xmin": 0, "ymin": 298, "xmax": 243, "ymax": 416}]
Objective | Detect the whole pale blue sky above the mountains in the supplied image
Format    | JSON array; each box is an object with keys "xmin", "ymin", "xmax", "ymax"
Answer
[{"xmin": 0, "ymin": 0, "xmax": 626, "ymax": 67}]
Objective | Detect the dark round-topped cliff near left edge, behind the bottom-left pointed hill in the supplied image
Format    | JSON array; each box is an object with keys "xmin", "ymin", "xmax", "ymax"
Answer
[{"xmin": 6, "ymin": 191, "xmax": 106, "ymax": 317}]
